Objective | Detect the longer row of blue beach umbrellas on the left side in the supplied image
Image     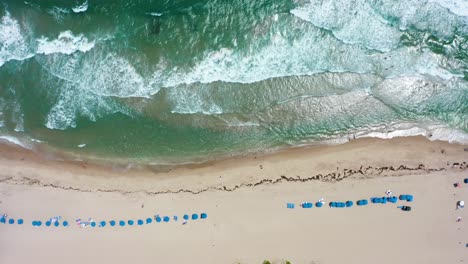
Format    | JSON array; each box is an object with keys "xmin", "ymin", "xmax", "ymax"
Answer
[{"xmin": 0, "ymin": 213, "xmax": 208, "ymax": 227}]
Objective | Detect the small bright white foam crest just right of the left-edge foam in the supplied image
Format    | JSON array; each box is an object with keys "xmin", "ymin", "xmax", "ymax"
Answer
[{"xmin": 37, "ymin": 31, "xmax": 94, "ymax": 55}]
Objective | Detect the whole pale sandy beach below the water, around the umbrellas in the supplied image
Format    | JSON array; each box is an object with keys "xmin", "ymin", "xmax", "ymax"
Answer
[{"xmin": 0, "ymin": 137, "xmax": 468, "ymax": 264}]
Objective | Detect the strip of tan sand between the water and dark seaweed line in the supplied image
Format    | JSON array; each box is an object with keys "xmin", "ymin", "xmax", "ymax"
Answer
[{"xmin": 0, "ymin": 137, "xmax": 468, "ymax": 193}]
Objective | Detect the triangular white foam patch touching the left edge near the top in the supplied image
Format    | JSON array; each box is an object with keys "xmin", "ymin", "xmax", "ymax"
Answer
[{"xmin": 0, "ymin": 12, "xmax": 34, "ymax": 66}]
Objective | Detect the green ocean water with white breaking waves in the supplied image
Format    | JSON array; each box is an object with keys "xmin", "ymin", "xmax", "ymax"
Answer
[{"xmin": 0, "ymin": 0, "xmax": 468, "ymax": 164}]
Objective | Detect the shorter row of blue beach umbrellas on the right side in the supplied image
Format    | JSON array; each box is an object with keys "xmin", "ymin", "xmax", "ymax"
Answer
[{"xmin": 286, "ymin": 194, "xmax": 414, "ymax": 209}]
